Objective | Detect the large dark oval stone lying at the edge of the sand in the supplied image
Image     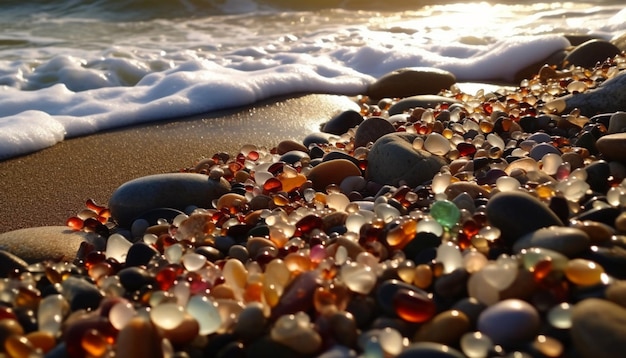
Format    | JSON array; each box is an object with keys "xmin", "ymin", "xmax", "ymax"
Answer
[{"xmin": 109, "ymin": 173, "xmax": 230, "ymax": 227}]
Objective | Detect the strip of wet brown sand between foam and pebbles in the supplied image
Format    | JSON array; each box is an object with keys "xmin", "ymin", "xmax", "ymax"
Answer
[{"xmin": 0, "ymin": 95, "xmax": 356, "ymax": 233}]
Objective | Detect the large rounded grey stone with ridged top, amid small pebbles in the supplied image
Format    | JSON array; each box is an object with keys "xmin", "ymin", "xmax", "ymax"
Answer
[{"xmin": 366, "ymin": 133, "xmax": 446, "ymax": 187}]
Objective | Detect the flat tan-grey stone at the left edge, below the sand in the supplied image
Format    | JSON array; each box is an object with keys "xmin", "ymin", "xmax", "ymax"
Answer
[{"xmin": 0, "ymin": 226, "xmax": 106, "ymax": 264}]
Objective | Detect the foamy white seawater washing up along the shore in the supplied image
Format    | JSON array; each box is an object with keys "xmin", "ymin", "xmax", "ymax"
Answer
[{"xmin": 0, "ymin": 0, "xmax": 626, "ymax": 160}]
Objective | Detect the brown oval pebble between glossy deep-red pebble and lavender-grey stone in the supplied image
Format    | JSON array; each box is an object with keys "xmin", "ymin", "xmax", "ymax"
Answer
[{"xmin": 415, "ymin": 310, "xmax": 470, "ymax": 345}]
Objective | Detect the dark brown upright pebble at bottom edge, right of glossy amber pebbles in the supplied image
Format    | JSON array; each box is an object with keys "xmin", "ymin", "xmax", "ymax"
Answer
[{"xmin": 115, "ymin": 316, "xmax": 163, "ymax": 357}]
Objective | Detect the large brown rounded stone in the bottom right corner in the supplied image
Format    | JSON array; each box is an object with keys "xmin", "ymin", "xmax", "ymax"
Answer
[{"xmin": 570, "ymin": 298, "xmax": 626, "ymax": 358}]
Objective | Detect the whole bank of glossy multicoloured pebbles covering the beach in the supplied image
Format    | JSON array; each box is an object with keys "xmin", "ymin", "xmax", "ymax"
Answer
[{"xmin": 0, "ymin": 49, "xmax": 626, "ymax": 358}]
